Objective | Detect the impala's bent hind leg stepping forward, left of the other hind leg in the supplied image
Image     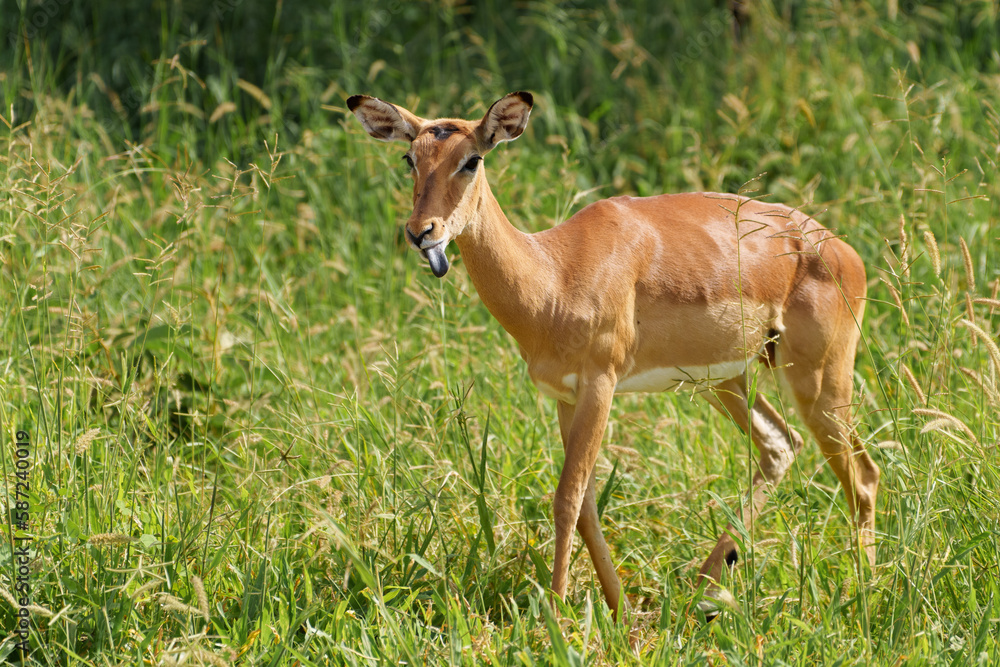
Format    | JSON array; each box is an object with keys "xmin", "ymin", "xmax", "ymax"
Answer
[{"xmin": 699, "ymin": 377, "xmax": 802, "ymax": 611}]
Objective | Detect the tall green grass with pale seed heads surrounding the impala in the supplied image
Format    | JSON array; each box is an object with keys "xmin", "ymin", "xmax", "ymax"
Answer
[{"xmin": 0, "ymin": 0, "xmax": 1000, "ymax": 666}]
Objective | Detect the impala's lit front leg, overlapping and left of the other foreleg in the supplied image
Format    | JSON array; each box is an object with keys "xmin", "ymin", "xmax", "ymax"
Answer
[{"xmin": 552, "ymin": 374, "xmax": 618, "ymax": 612}]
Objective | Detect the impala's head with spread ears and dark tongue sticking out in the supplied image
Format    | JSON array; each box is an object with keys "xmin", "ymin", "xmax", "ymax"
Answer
[{"xmin": 347, "ymin": 92, "xmax": 532, "ymax": 278}]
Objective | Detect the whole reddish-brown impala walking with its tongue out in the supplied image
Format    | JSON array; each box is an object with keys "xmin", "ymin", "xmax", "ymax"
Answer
[{"xmin": 347, "ymin": 92, "xmax": 879, "ymax": 617}]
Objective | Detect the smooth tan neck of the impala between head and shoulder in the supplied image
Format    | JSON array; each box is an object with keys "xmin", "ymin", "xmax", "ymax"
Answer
[{"xmin": 455, "ymin": 174, "xmax": 555, "ymax": 345}]
